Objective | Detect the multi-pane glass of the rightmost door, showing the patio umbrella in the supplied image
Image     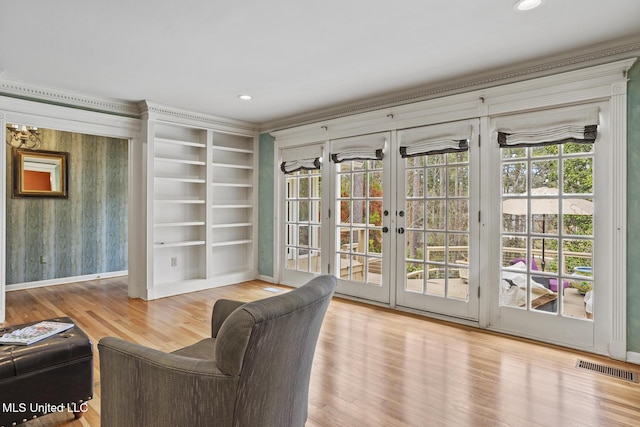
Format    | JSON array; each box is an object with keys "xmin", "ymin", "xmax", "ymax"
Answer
[{"xmin": 500, "ymin": 143, "xmax": 595, "ymax": 321}]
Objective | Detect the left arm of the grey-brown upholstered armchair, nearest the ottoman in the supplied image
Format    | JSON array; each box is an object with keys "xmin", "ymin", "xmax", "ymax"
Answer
[{"xmin": 98, "ymin": 337, "xmax": 238, "ymax": 426}]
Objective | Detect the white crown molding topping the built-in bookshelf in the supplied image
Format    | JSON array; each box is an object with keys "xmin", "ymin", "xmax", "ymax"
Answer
[{"xmin": 138, "ymin": 100, "xmax": 258, "ymax": 136}]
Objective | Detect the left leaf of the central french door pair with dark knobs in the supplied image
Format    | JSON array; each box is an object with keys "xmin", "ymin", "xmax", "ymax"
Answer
[{"xmin": 330, "ymin": 132, "xmax": 392, "ymax": 303}]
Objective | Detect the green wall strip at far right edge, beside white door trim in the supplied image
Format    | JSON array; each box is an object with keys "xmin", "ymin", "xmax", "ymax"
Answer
[{"xmin": 627, "ymin": 61, "xmax": 640, "ymax": 353}]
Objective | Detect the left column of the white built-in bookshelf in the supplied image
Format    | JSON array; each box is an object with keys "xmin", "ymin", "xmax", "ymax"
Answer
[{"xmin": 152, "ymin": 123, "xmax": 207, "ymax": 286}]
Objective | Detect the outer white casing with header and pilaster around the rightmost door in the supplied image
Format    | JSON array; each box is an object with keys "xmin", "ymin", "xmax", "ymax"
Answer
[{"xmin": 480, "ymin": 60, "xmax": 634, "ymax": 360}]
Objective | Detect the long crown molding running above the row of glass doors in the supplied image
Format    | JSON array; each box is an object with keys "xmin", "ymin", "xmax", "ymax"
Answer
[{"xmin": 260, "ymin": 34, "xmax": 640, "ymax": 132}]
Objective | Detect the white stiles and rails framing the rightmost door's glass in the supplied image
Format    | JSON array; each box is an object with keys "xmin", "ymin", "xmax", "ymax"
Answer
[{"xmin": 484, "ymin": 102, "xmax": 615, "ymax": 350}]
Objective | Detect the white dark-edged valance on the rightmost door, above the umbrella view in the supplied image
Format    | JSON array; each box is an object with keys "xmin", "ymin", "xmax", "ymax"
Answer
[{"xmin": 496, "ymin": 107, "xmax": 600, "ymax": 147}]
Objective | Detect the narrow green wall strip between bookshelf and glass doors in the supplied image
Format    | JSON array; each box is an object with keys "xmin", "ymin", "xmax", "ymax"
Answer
[{"xmin": 258, "ymin": 134, "xmax": 275, "ymax": 277}]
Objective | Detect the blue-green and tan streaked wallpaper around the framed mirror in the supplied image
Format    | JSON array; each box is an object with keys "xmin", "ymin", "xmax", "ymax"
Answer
[{"xmin": 6, "ymin": 129, "xmax": 128, "ymax": 285}]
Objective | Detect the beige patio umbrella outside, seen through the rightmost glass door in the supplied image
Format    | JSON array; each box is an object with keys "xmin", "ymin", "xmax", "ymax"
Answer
[{"xmin": 502, "ymin": 187, "xmax": 593, "ymax": 270}]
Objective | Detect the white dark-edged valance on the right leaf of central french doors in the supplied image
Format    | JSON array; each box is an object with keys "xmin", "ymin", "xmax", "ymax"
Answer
[{"xmin": 398, "ymin": 125, "xmax": 472, "ymax": 158}]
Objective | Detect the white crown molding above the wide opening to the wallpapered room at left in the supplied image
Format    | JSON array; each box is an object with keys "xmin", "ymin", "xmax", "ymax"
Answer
[{"xmin": 0, "ymin": 80, "xmax": 140, "ymax": 118}]
